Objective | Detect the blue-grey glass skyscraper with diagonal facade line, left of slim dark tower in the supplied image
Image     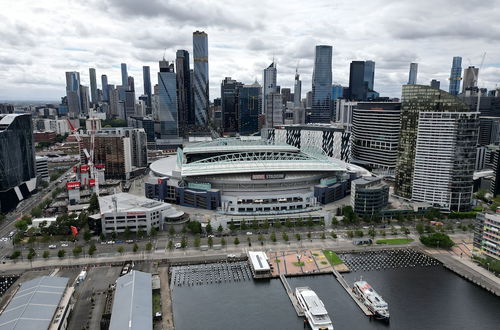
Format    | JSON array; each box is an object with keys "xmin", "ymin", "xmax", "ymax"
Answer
[{"xmin": 158, "ymin": 59, "xmax": 179, "ymax": 139}]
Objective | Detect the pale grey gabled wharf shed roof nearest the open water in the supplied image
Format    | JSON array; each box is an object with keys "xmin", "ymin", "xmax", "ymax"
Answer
[{"xmin": 109, "ymin": 270, "xmax": 153, "ymax": 330}]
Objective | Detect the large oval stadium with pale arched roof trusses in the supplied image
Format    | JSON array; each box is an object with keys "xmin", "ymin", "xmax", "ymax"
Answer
[{"xmin": 146, "ymin": 138, "xmax": 364, "ymax": 216}]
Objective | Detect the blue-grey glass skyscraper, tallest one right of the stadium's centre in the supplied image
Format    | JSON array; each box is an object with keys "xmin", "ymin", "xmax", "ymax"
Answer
[{"xmin": 310, "ymin": 45, "xmax": 332, "ymax": 123}]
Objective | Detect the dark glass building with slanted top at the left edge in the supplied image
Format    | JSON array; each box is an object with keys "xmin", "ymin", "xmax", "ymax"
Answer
[{"xmin": 0, "ymin": 114, "xmax": 36, "ymax": 213}]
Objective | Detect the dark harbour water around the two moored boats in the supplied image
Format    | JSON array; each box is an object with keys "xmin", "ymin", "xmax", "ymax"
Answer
[{"xmin": 171, "ymin": 266, "xmax": 500, "ymax": 330}]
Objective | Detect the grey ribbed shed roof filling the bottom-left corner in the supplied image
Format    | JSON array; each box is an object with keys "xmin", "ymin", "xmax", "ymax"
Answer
[{"xmin": 0, "ymin": 276, "xmax": 69, "ymax": 330}]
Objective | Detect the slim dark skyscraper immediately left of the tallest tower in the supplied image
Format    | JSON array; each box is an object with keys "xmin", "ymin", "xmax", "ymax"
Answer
[{"xmin": 175, "ymin": 49, "xmax": 191, "ymax": 135}]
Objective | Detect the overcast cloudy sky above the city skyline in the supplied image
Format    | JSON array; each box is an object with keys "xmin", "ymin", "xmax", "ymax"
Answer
[{"xmin": 0, "ymin": 0, "xmax": 500, "ymax": 100}]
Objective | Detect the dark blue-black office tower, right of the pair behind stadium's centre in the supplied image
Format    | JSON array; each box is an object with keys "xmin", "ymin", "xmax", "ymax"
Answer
[{"xmin": 238, "ymin": 81, "xmax": 262, "ymax": 135}]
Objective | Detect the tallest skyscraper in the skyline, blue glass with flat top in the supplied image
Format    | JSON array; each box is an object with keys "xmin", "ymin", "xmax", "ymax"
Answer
[{"xmin": 193, "ymin": 31, "xmax": 209, "ymax": 126}]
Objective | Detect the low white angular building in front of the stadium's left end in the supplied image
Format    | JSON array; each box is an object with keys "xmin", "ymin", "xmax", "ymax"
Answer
[{"xmin": 99, "ymin": 193, "xmax": 184, "ymax": 234}]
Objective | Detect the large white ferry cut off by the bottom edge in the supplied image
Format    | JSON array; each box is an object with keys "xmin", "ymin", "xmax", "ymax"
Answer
[{"xmin": 295, "ymin": 287, "xmax": 333, "ymax": 330}]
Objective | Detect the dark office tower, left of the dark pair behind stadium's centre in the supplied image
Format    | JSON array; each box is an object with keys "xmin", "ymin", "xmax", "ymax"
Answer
[{"xmin": 221, "ymin": 77, "xmax": 243, "ymax": 133}]
